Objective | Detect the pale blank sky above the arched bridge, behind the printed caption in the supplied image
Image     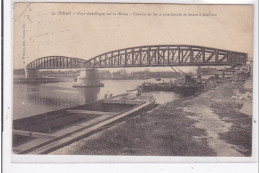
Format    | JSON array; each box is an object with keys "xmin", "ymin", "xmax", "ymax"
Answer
[{"xmin": 13, "ymin": 3, "xmax": 253, "ymax": 69}]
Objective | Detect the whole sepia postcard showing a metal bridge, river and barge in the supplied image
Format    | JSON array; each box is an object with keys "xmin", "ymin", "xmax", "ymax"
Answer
[{"xmin": 12, "ymin": 2, "xmax": 257, "ymax": 161}]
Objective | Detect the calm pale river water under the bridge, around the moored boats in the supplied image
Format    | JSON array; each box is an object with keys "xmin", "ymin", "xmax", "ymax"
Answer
[{"xmin": 13, "ymin": 79, "xmax": 181, "ymax": 119}]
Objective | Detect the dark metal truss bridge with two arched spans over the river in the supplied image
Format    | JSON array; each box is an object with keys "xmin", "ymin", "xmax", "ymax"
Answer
[{"xmin": 26, "ymin": 45, "xmax": 248, "ymax": 70}]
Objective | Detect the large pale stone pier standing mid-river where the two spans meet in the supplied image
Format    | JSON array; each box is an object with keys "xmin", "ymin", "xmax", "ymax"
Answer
[{"xmin": 73, "ymin": 69, "xmax": 103, "ymax": 87}]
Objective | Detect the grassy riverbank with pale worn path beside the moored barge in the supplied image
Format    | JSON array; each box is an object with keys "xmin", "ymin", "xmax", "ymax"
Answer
[{"xmin": 51, "ymin": 79, "xmax": 252, "ymax": 157}]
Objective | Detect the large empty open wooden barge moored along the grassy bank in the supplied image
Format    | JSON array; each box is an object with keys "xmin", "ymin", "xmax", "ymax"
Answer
[{"xmin": 13, "ymin": 94, "xmax": 156, "ymax": 154}]
